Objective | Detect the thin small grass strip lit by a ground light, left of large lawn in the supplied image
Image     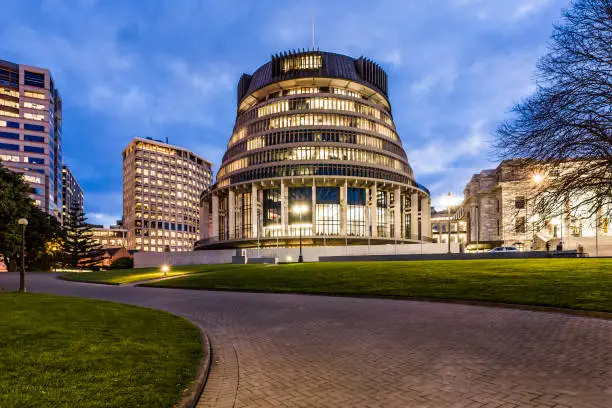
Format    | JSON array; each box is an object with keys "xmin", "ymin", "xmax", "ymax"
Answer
[{"xmin": 61, "ymin": 265, "xmax": 226, "ymax": 285}]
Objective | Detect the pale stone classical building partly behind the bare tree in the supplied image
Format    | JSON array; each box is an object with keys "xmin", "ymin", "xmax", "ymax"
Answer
[{"xmin": 454, "ymin": 159, "xmax": 612, "ymax": 254}]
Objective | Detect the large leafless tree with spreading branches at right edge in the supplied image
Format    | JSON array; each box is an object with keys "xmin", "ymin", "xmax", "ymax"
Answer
[{"xmin": 496, "ymin": 0, "xmax": 612, "ymax": 222}]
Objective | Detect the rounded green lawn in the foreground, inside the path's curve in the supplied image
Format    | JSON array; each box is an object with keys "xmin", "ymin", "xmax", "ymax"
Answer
[{"xmin": 0, "ymin": 293, "xmax": 202, "ymax": 408}]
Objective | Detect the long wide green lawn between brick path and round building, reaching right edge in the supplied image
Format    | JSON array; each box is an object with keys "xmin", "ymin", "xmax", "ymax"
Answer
[{"xmin": 147, "ymin": 259, "xmax": 612, "ymax": 312}]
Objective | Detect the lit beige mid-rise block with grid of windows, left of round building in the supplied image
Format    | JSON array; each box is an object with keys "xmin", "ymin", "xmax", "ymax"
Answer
[{"xmin": 123, "ymin": 137, "xmax": 212, "ymax": 252}]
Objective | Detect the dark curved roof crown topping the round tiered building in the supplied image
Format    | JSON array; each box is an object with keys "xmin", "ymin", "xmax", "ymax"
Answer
[{"xmin": 238, "ymin": 50, "xmax": 388, "ymax": 105}]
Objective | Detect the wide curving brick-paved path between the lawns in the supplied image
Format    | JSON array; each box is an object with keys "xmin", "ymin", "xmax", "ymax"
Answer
[{"xmin": 0, "ymin": 274, "xmax": 612, "ymax": 408}]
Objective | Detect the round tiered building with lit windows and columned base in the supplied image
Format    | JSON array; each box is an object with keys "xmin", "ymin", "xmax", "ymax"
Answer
[{"xmin": 196, "ymin": 51, "xmax": 430, "ymax": 249}]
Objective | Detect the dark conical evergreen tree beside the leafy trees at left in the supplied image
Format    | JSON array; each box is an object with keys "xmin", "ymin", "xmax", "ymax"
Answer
[{"xmin": 62, "ymin": 205, "xmax": 102, "ymax": 268}]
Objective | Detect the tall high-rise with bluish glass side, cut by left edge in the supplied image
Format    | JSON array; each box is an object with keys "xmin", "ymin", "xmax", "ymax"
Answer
[{"xmin": 0, "ymin": 60, "xmax": 62, "ymax": 221}]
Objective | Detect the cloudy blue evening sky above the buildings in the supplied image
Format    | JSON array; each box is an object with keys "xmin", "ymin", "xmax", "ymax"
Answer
[{"xmin": 0, "ymin": 0, "xmax": 569, "ymax": 224}]
